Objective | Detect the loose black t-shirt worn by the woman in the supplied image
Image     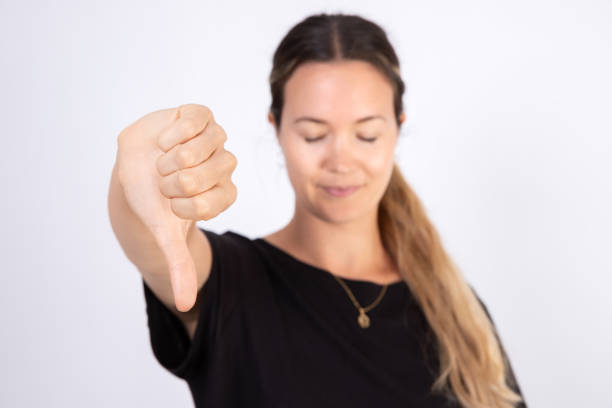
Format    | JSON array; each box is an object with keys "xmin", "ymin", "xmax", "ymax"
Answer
[{"xmin": 142, "ymin": 227, "xmax": 524, "ymax": 408}]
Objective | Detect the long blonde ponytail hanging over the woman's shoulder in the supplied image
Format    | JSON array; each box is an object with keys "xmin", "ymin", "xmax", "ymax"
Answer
[{"xmin": 378, "ymin": 164, "xmax": 522, "ymax": 408}]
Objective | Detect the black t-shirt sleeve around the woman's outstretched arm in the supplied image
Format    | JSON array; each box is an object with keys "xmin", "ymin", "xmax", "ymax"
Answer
[{"xmin": 142, "ymin": 227, "xmax": 244, "ymax": 380}]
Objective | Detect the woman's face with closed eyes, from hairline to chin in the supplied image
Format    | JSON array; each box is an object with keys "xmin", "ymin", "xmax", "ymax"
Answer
[{"xmin": 269, "ymin": 60, "xmax": 404, "ymax": 222}]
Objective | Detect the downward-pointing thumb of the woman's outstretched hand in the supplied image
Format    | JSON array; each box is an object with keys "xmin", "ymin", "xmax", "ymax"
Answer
[{"xmin": 153, "ymin": 222, "xmax": 198, "ymax": 312}]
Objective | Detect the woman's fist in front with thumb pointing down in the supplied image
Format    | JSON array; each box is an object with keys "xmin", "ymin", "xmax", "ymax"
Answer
[{"xmin": 116, "ymin": 104, "xmax": 237, "ymax": 311}]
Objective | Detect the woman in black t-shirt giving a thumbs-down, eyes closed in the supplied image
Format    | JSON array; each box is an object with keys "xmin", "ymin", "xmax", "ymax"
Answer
[{"xmin": 109, "ymin": 14, "xmax": 526, "ymax": 407}]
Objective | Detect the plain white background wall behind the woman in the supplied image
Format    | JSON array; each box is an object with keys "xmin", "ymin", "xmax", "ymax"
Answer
[{"xmin": 0, "ymin": 0, "xmax": 612, "ymax": 408}]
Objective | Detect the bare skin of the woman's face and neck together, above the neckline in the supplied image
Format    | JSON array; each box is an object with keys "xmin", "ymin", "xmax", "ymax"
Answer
[{"xmin": 263, "ymin": 60, "xmax": 405, "ymax": 284}]
